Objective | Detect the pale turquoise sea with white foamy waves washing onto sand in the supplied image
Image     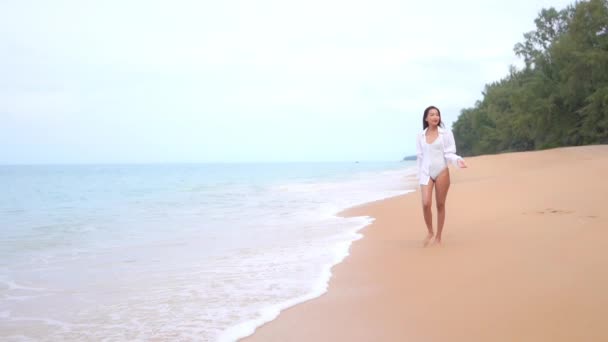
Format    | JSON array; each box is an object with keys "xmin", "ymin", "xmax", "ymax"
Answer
[{"xmin": 0, "ymin": 162, "xmax": 415, "ymax": 341}]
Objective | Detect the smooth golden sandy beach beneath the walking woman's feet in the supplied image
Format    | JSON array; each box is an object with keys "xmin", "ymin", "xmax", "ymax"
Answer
[{"xmin": 244, "ymin": 145, "xmax": 608, "ymax": 342}]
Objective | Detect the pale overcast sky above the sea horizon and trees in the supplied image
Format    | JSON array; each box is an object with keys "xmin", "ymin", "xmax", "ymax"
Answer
[{"xmin": 0, "ymin": 0, "xmax": 573, "ymax": 164}]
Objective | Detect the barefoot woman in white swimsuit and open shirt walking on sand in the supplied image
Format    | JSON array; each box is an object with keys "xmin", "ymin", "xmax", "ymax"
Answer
[{"xmin": 416, "ymin": 106, "xmax": 467, "ymax": 247}]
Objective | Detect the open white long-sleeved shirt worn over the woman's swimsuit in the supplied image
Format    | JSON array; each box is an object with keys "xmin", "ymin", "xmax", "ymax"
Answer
[{"xmin": 416, "ymin": 127, "xmax": 462, "ymax": 185}]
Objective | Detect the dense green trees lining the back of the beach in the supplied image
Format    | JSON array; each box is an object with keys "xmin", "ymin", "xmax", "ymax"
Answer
[{"xmin": 452, "ymin": 0, "xmax": 608, "ymax": 156}]
